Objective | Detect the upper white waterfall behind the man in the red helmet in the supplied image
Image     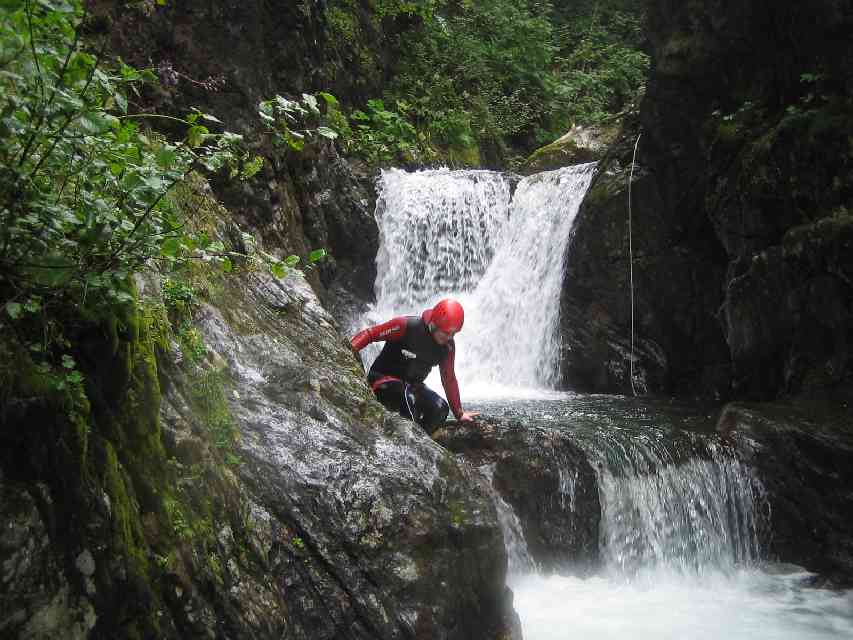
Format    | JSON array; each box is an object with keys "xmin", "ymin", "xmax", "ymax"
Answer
[{"xmin": 367, "ymin": 164, "xmax": 595, "ymax": 395}]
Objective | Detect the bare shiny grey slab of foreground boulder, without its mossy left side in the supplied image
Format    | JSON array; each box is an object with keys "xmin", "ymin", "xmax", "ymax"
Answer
[{"xmin": 167, "ymin": 274, "xmax": 519, "ymax": 639}]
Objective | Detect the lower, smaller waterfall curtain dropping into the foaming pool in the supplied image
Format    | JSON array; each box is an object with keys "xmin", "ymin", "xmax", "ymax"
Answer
[{"xmin": 588, "ymin": 434, "xmax": 767, "ymax": 578}]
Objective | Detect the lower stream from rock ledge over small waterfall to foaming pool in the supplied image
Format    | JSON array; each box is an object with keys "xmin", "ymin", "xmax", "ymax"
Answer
[{"xmin": 476, "ymin": 394, "xmax": 853, "ymax": 640}]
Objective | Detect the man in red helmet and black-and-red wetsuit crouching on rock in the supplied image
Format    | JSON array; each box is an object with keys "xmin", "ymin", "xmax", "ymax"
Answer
[{"xmin": 351, "ymin": 298, "xmax": 478, "ymax": 431}]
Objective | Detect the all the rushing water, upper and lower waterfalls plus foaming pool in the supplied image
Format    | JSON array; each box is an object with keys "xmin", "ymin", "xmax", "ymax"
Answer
[{"xmin": 362, "ymin": 165, "xmax": 853, "ymax": 640}]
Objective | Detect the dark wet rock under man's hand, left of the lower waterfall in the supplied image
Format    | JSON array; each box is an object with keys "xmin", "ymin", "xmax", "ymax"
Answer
[{"xmin": 433, "ymin": 419, "xmax": 601, "ymax": 573}]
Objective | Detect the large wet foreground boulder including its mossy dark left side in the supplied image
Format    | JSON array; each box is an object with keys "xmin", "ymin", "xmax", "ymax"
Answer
[{"xmin": 0, "ymin": 264, "xmax": 520, "ymax": 640}]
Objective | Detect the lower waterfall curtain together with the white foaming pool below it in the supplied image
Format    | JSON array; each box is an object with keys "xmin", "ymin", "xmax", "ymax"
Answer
[{"xmin": 510, "ymin": 433, "xmax": 853, "ymax": 640}]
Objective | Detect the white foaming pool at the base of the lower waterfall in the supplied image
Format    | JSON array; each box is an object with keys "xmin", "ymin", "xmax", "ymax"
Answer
[{"xmin": 511, "ymin": 568, "xmax": 853, "ymax": 640}]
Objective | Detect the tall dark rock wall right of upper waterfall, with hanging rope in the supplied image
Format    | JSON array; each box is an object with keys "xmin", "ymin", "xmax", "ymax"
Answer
[{"xmin": 562, "ymin": 1, "xmax": 853, "ymax": 397}]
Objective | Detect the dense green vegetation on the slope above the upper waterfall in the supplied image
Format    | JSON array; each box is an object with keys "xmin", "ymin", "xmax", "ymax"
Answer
[{"xmin": 326, "ymin": 0, "xmax": 648, "ymax": 164}]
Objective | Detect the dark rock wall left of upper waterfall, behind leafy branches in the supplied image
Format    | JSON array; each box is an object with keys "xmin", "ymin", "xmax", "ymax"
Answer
[{"xmin": 99, "ymin": 0, "xmax": 382, "ymax": 317}]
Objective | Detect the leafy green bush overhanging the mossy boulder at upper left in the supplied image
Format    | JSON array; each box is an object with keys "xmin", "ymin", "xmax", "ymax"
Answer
[{"xmin": 0, "ymin": 0, "xmax": 326, "ymax": 385}]
